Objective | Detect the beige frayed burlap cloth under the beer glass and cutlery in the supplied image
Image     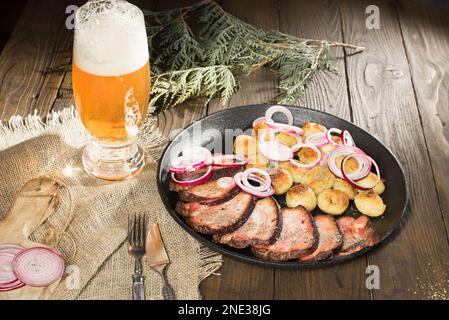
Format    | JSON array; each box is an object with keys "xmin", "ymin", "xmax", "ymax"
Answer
[{"xmin": 0, "ymin": 108, "xmax": 222, "ymax": 300}]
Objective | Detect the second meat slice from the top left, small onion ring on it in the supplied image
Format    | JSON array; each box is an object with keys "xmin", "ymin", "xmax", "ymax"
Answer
[{"xmin": 179, "ymin": 177, "xmax": 240, "ymax": 205}]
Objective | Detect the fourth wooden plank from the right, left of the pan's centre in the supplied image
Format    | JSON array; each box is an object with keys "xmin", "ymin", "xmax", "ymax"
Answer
[{"xmin": 201, "ymin": 0, "xmax": 279, "ymax": 300}]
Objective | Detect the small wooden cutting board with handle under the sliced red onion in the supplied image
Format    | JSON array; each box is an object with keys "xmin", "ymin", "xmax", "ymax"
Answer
[{"xmin": 0, "ymin": 177, "xmax": 61, "ymax": 300}]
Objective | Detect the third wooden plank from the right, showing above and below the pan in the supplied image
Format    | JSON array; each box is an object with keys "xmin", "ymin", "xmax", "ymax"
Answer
[{"xmin": 275, "ymin": 0, "xmax": 370, "ymax": 299}]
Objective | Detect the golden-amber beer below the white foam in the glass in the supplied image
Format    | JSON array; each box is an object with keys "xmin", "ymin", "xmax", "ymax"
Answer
[{"xmin": 72, "ymin": 62, "xmax": 150, "ymax": 141}]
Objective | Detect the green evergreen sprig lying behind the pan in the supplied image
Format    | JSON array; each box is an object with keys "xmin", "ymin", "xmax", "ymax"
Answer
[{"xmin": 144, "ymin": 0, "xmax": 364, "ymax": 109}]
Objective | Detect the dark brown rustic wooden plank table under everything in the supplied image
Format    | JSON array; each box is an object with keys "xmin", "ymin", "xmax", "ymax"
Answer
[{"xmin": 0, "ymin": 0, "xmax": 449, "ymax": 299}]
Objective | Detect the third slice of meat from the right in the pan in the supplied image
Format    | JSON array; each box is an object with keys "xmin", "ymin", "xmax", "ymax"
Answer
[{"xmin": 252, "ymin": 207, "xmax": 318, "ymax": 261}]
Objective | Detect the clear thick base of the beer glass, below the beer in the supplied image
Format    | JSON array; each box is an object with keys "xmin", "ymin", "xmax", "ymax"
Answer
[{"xmin": 83, "ymin": 140, "xmax": 145, "ymax": 181}]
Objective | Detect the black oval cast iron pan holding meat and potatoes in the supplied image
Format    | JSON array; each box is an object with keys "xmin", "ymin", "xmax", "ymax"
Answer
[{"xmin": 157, "ymin": 105, "xmax": 408, "ymax": 269}]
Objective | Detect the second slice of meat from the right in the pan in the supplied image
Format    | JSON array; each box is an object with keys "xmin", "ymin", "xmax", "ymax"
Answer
[{"xmin": 299, "ymin": 214, "xmax": 343, "ymax": 262}]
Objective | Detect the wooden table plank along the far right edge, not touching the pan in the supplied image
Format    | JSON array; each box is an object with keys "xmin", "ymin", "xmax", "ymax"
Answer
[{"xmin": 399, "ymin": 0, "xmax": 449, "ymax": 255}]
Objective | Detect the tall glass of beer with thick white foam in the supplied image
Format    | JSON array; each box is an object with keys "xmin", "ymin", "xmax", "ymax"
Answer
[{"xmin": 72, "ymin": 0, "xmax": 150, "ymax": 180}]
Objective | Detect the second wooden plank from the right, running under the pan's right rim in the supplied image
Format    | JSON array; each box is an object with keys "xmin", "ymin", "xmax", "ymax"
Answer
[{"xmin": 341, "ymin": 0, "xmax": 449, "ymax": 299}]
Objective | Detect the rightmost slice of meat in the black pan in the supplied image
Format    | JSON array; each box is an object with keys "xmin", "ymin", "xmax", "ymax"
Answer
[{"xmin": 337, "ymin": 216, "xmax": 380, "ymax": 256}]
